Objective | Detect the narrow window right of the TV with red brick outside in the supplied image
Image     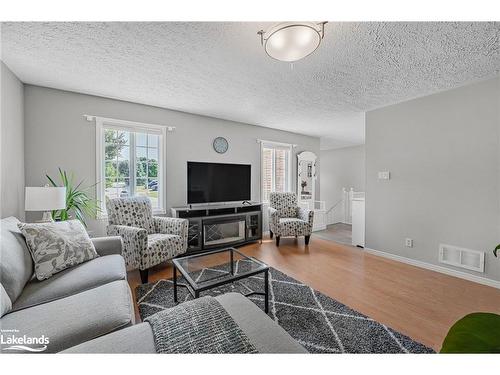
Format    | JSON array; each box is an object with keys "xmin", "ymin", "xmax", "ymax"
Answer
[{"xmin": 261, "ymin": 142, "xmax": 292, "ymax": 202}]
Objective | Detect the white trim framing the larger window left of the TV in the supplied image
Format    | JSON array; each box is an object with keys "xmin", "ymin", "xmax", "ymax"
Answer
[{"xmin": 94, "ymin": 116, "xmax": 169, "ymax": 219}]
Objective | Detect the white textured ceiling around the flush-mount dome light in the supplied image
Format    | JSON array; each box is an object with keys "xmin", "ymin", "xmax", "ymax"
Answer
[{"xmin": 2, "ymin": 22, "xmax": 500, "ymax": 148}]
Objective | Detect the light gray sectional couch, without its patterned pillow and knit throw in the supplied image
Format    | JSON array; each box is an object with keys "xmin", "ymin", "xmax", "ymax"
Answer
[{"xmin": 0, "ymin": 217, "xmax": 306, "ymax": 353}]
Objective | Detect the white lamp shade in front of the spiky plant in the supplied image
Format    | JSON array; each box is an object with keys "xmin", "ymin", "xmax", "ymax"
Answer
[{"xmin": 24, "ymin": 186, "xmax": 66, "ymax": 211}]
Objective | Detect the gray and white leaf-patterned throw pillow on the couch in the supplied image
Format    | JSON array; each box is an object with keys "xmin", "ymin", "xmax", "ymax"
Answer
[{"xmin": 18, "ymin": 220, "xmax": 98, "ymax": 280}]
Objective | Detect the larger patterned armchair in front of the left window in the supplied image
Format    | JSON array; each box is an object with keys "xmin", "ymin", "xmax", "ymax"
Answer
[{"xmin": 106, "ymin": 197, "xmax": 188, "ymax": 283}]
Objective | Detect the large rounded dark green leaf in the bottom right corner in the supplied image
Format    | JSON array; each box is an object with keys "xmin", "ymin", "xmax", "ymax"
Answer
[{"xmin": 441, "ymin": 313, "xmax": 500, "ymax": 353}]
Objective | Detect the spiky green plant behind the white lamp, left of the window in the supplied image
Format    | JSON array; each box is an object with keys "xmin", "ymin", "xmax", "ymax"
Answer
[{"xmin": 45, "ymin": 168, "xmax": 101, "ymax": 227}]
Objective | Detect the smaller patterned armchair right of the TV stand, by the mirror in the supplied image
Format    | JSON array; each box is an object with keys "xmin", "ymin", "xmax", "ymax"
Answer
[{"xmin": 269, "ymin": 192, "xmax": 314, "ymax": 246}]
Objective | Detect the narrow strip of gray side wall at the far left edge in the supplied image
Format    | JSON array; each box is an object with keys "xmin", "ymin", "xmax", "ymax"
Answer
[{"xmin": 0, "ymin": 61, "xmax": 24, "ymax": 219}]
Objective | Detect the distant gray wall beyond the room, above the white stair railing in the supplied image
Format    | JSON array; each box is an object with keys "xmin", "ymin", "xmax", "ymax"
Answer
[{"xmin": 320, "ymin": 145, "xmax": 365, "ymax": 223}]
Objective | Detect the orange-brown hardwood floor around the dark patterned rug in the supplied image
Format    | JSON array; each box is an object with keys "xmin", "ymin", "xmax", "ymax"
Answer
[{"xmin": 129, "ymin": 234, "xmax": 500, "ymax": 350}]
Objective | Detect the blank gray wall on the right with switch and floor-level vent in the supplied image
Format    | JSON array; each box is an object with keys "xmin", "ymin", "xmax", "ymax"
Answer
[{"xmin": 366, "ymin": 78, "xmax": 500, "ymax": 280}]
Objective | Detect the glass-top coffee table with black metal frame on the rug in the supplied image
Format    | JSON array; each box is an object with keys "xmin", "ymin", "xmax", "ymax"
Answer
[{"xmin": 173, "ymin": 247, "xmax": 269, "ymax": 313}]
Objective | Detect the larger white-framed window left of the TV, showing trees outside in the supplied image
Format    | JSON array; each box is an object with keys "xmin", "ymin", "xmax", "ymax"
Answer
[{"xmin": 96, "ymin": 118, "xmax": 165, "ymax": 214}]
